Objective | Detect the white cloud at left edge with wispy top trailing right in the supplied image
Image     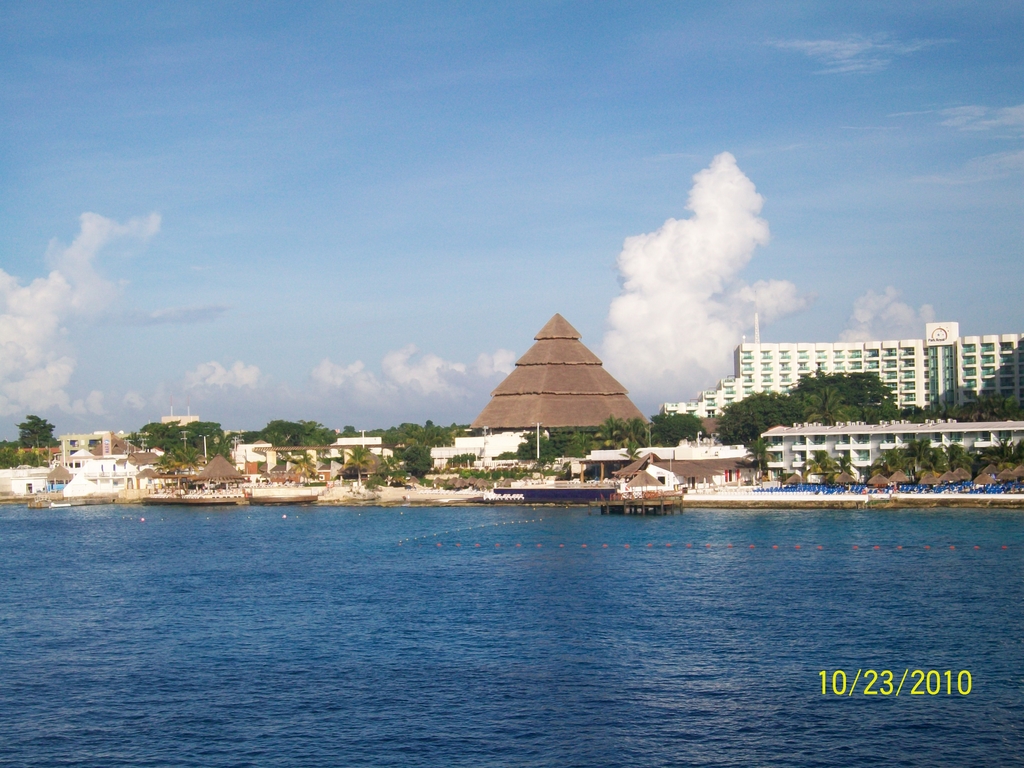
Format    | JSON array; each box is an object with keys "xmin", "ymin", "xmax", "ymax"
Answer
[{"xmin": 0, "ymin": 213, "xmax": 160, "ymax": 416}]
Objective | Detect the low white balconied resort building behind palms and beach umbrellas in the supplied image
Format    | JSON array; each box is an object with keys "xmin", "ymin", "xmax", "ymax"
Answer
[{"xmin": 762, "ymin": 419, "xmax": 1024, "ymax": 476}]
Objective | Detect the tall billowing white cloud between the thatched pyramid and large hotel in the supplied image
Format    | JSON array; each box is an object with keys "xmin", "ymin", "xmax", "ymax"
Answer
[{"xmin": 604, "ymin": 153, "xmax": 808, "ymax": 398}]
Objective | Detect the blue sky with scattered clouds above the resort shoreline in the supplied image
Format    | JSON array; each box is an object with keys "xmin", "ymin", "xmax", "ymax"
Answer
[{"xmin": 0, "ymin": 2, "xmax": 1024, "ymax": 436}]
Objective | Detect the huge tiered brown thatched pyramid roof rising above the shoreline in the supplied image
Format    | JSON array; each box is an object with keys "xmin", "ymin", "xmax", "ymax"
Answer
[{"xmin": 472, "ymin": 314, "xmax": 646, "ymax": 429}]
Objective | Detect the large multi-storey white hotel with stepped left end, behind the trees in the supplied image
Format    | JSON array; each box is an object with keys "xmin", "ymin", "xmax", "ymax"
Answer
[{"xmin": 662, "ymin": 323, "xmax": 1024, "ymax": 418}]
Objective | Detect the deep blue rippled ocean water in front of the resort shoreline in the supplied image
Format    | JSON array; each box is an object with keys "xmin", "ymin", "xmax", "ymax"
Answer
[{"xmin": 0, "ymin": 506, "xmax": 1024, "ymax": 768}]
